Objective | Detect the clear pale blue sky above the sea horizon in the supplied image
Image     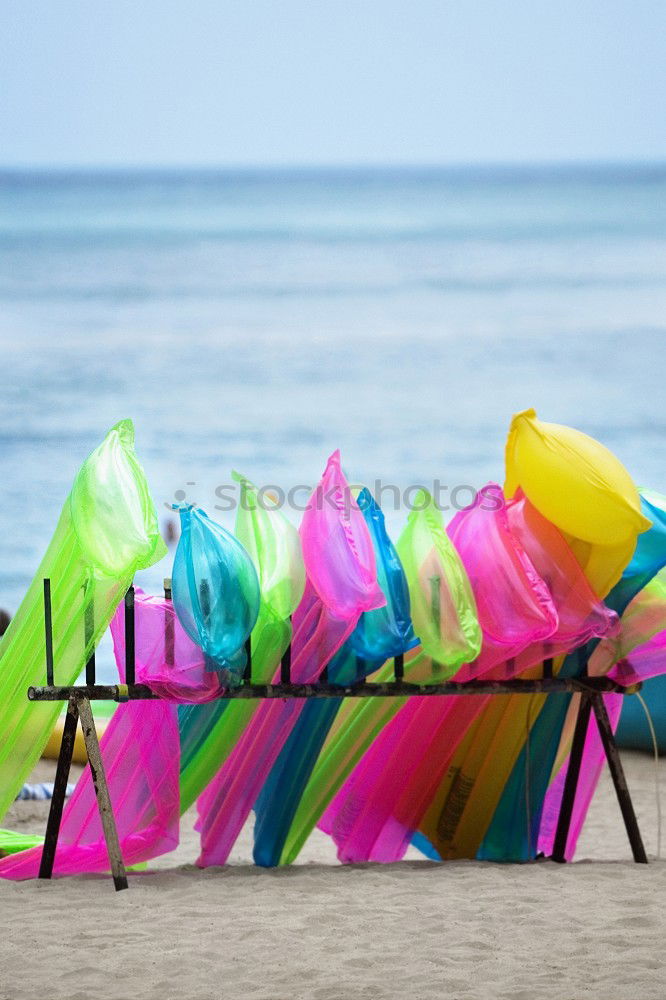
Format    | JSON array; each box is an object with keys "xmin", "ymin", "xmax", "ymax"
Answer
[{"xmin": 0, "ymin": 0, "xmax": 666, "ymax": 167}]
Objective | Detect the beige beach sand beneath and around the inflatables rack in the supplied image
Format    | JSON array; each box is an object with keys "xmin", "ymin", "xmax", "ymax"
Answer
[{"xmin": 0, "ymin": 752, "xmax": 666, "ymax": 1000}]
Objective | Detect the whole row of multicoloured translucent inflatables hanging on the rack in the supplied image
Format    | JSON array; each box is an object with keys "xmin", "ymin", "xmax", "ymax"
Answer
[{"xmin": 0, "ymin": 410, "xmax": 666, "ymax": 878}]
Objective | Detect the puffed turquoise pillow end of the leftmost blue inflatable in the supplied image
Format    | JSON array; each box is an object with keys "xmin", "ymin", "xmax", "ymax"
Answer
[{"xmin": 172, "ymin": 506, "xmax": 260, "ymax": 685}]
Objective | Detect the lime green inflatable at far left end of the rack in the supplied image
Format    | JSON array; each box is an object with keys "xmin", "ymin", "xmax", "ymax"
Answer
[{"xmin": 0, "ymin": 420, "xmax": 166, "ymax": 817}]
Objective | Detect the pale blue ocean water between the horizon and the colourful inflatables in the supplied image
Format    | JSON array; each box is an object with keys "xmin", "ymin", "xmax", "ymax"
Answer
[{"xmin": 0, "ymin": 167, "xmax": 666, "ymax": 680}]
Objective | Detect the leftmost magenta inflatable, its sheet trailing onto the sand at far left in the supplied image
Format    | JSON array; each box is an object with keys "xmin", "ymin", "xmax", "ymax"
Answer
[{"xmin": 0, "ymin": 589, "xmax": 183, "ymax": 879}]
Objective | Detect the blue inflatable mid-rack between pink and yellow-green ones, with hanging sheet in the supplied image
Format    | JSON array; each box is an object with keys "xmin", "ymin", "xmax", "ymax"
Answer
[{"xmin": 254, "ymin": 490, "xmax": 418, "ymax": 867}]
